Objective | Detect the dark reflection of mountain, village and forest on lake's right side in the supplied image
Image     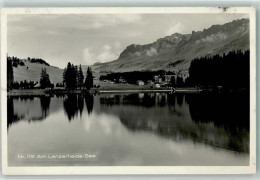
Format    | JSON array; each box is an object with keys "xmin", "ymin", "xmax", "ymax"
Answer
[{"xmin": 100, "ymin": 94, "xmax": 249, "ymax": 153}]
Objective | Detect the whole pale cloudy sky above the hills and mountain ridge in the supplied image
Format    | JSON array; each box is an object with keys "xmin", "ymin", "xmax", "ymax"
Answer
[{"xmin": 7, "ymin": 13, "xmax": 248, "ymax": 68}]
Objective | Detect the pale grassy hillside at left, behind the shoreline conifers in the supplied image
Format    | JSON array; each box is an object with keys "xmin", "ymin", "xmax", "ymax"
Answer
[{"xmin": 13, "ymin": 59, "xmax": 63, "ymax": 84}]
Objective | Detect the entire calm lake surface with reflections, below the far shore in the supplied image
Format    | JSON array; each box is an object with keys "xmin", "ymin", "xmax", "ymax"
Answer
[{"xmin": 7, "ymin": 93, "xmax": 249, "ymax": 166}]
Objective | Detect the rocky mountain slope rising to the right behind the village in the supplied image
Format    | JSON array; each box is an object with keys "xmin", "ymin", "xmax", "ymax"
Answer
[{"xmin": 92, "ymin": 19, "xmax": 249, "ymax": 74}]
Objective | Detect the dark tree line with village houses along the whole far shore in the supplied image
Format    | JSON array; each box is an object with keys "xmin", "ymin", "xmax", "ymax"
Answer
[{"xmin": 7, "ymin": 50, "xmax": 250, "ymax": 95}]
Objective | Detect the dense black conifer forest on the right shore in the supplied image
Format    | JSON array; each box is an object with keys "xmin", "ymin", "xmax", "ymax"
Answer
[{"xmin": 189, "ymin": 50, "xmax": 250, "ymax": 89}]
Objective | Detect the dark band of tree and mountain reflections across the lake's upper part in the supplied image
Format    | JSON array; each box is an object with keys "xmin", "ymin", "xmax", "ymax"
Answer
[{"xmin": 7, "ymin": 93, "xmax": 250, "ymax": 165}]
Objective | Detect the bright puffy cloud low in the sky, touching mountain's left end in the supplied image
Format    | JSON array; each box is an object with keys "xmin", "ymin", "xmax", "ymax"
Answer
[{"xmin": 83, "ymin": 41, "xmax": 121, "ymax": 65}]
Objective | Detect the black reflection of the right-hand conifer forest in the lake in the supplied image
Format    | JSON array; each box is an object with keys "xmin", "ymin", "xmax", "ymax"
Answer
[{"xmin": 186, "ymin": 94, "xmax": 249, "ymax": 132}]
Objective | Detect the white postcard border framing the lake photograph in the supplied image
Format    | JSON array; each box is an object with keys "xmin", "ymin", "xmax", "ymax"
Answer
[{"xmin": 1, "ymin": 7, "xmax": 256, "ymax": 175}]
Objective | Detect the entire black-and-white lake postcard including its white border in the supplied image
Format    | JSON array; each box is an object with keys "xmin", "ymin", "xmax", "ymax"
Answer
[{"xmin": 1, "ymin": 7, "xmax": 255, "ymax": 174}]
